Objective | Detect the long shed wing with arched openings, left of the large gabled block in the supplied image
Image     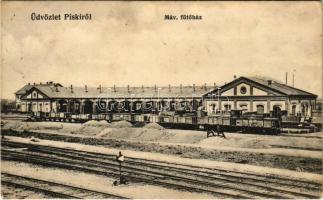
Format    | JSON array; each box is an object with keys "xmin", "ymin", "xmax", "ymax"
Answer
[{"xmin": 15, "ymin": 82, "xmax": 212, "ymax": 114}]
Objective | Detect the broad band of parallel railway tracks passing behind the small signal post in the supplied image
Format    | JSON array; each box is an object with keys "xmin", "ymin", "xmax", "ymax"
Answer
[{"xmin": 2, "ymin": 142, "xmax": 321, "ymax": 199}]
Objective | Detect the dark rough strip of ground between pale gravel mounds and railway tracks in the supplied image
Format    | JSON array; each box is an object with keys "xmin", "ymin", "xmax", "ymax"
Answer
[{"xmin": 1, "ymin": 131, "xmax": 323, "ymax": 174}]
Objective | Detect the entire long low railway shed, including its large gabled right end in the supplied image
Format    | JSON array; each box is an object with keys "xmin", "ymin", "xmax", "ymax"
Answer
[{"xmin": 15, "ymin": 77, "xmax": 317, "ymax": 116}]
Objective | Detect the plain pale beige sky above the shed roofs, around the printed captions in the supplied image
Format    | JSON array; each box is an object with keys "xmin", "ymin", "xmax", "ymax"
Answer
[{"xmin": 1, "ymin": 1, "xmax": 322, "ymax": 99}]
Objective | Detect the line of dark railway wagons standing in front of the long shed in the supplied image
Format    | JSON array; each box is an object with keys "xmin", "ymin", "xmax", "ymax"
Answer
[{"xmin": 34, "ymin": 111, "xmax": 280, "ymax": 134}]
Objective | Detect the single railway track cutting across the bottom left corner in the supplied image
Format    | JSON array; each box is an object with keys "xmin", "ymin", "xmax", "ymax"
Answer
[{"xmin": 1, "ymin": 172, "xmax": 125, "ymax": 199}]
